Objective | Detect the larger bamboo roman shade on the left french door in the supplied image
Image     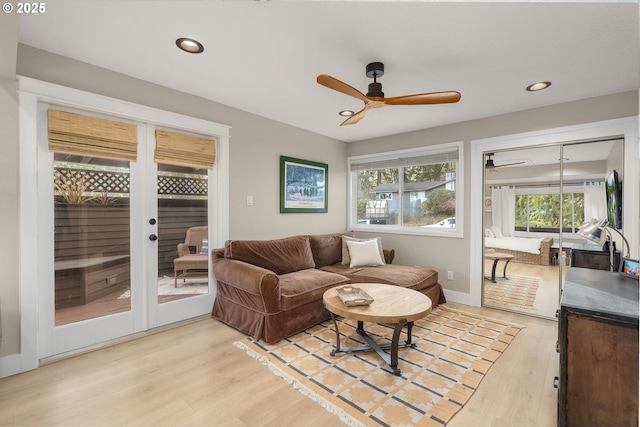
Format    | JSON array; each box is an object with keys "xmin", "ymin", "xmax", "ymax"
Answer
[{"xmin": 48, "ymin": 109, "xmax": 138, "ymax": 161}]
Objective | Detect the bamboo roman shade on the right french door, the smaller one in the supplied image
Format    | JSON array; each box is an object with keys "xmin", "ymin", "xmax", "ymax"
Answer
[{"xmin": 155, "ymin": 129, "xmax": 216, "ymax": 169}]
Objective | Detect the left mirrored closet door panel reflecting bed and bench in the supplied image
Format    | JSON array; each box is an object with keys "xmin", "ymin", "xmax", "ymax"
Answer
[{"xmin": 483, "ymin": 146, "xmax": 562, "ymax": 318}]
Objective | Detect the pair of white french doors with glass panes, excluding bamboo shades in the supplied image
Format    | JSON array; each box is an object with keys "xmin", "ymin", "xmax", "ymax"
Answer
[{"xmin": 34, "ymin": 104, "xmax": 219, "ymax": 359}]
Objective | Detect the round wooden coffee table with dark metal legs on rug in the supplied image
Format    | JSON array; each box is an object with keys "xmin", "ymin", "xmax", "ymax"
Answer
[{"xmin": 322, "ymin": 283, "xmax": 431, "ymax": 375}]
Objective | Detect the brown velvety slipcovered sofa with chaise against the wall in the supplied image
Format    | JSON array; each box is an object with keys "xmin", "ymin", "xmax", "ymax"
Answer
[{"xmin": 212, "ymin": 232, "xmax": 446, "ymax": 343}]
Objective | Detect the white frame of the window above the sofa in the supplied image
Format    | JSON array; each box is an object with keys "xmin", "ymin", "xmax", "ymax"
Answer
[{"xmin": 347, "ymin": 141, "xmax": 465, "ymax": 238}]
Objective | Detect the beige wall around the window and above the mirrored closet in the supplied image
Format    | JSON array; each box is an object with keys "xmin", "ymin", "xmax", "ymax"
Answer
[{"xmin": 348, "ymin": 91, "xmax": 638, "ymax": 294}]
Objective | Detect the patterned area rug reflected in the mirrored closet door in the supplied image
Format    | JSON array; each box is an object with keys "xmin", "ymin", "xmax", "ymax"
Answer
[{"xmin": 484, "ymin": 276, "xmax": 540, "ymax": 308}]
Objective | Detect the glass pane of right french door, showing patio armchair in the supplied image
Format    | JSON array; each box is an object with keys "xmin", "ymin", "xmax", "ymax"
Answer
[{"xmin": 157, "ymin": 164, "xmax": 209, "ymax": 304}]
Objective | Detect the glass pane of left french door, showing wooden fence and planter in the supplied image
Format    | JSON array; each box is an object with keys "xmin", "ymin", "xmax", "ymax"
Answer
[{"xmin": 53, "ymin": 153, "xmax": 131, "ymax": 326}]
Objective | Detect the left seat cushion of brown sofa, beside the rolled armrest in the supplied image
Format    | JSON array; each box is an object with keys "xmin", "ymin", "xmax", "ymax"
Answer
[{"xmin": 279, "ymin": 268, "xmax": 349, "ymax": 311}]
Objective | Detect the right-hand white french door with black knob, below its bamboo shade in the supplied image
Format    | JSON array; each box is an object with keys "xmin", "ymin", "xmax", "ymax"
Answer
[{"xmin": 143, "ymin": 126, "xmax": 215, "ymax": 327}]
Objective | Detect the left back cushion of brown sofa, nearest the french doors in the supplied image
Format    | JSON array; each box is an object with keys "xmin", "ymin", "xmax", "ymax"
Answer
[{"xmin": 224, "ymin": 236, "xmax": 315, "ymax": 274}]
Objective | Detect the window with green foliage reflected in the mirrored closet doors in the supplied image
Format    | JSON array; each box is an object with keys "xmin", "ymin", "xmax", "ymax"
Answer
[{"xmin": 515, "ymin": 189, "xmax": 585, "ymax": 233}]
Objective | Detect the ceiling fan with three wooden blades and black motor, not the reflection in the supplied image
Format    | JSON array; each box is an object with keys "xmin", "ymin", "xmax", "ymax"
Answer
[{"xmin": 316, "ymin": 62, "xmax": 461, "ymax": 126}]
